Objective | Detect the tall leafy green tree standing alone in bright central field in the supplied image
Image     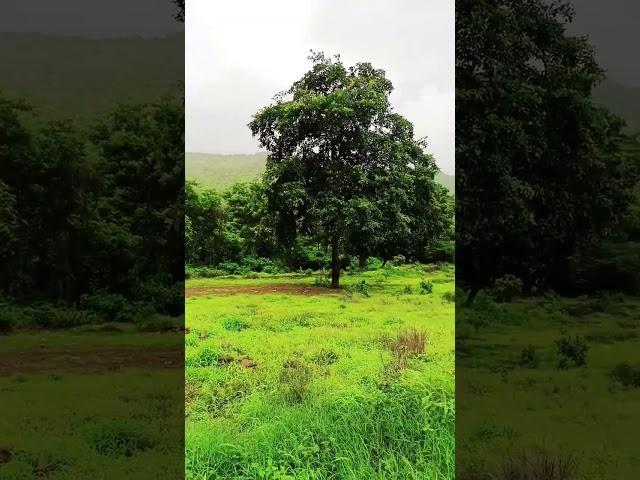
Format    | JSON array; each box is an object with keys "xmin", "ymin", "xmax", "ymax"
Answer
[{"xmin": 249, "ymin": 53, "xmax": 444, "ymax": 288}]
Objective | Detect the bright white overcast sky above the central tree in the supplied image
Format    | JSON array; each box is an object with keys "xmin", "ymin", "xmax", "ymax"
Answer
[{"xmin": 185, "ymin": 0, "xmax": 455, "ymax": 173}]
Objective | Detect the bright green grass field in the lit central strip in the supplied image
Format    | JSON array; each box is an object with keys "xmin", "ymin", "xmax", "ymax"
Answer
[{"xmin": 185, "ymin": 266, "xmax": 455, "ymax": 480}]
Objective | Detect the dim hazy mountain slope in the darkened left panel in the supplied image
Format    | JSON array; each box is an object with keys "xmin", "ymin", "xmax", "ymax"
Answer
[{"xmin": 0, "ymin": 33, "xmax": 184, "ymax": 120}]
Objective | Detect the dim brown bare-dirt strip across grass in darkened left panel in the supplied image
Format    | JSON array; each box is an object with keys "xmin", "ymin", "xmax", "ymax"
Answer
[{"xmin": 0, "ymin": 347, "xmax": 184, "ymax": 377}]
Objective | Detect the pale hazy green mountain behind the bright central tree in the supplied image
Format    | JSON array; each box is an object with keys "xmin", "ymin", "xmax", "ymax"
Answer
[{"xmin": 185, "ymin": 153, "xmax": 455, "ymax": 193}]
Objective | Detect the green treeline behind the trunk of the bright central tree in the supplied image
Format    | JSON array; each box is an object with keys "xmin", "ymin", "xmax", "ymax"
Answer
[{"xmin": 185, "ymin": 180, "xmax": 455, "ymax": 276}]
